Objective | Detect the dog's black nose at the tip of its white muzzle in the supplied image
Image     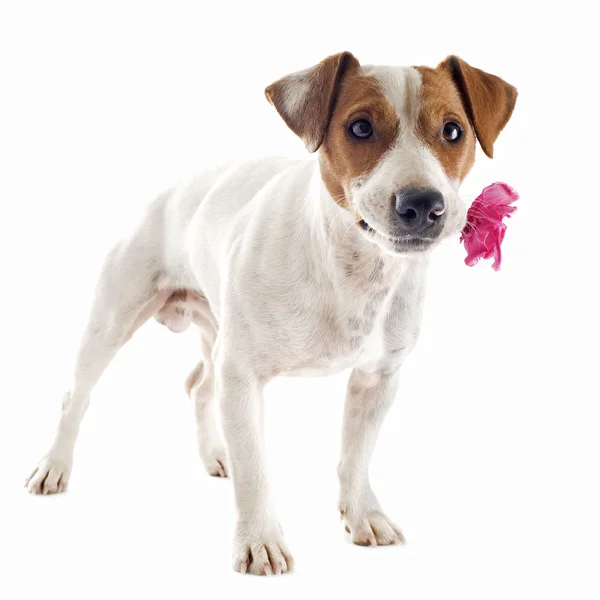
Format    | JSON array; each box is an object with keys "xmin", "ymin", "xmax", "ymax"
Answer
[{"xmin": 396, "ymin": 188, "xmax": 446, "ymax": 234}]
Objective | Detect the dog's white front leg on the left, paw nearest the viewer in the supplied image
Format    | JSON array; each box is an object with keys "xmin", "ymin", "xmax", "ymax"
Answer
[{"xmin": 215, "ymin": 354, "xmax": 292, "ymax": 575}]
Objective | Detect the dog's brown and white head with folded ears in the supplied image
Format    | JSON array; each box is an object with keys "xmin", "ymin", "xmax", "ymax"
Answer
[{"xmin": 265, "ymin": 52, "xmax": 517, "ymax": 253}]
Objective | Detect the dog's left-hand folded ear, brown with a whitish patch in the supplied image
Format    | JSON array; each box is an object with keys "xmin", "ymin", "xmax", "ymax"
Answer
[{"xmin": 265, "ymin": 52, "xmax": 359, "ymax": 152}]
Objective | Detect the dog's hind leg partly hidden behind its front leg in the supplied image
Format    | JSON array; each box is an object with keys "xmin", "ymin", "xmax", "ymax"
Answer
[{"xmin": 185, "ymin": 304, "xmax": 229, "ymax": 477}]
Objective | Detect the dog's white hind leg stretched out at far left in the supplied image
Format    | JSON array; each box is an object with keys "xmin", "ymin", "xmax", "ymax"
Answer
[{"xmin": 25, "ymin": 239, "xmax": 164, "ymax": 494}]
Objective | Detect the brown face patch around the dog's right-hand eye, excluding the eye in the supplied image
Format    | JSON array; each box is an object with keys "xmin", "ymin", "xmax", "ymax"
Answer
[{"xmin": 415, "ymin": 67, "xmax": 475, "ymax": 181}]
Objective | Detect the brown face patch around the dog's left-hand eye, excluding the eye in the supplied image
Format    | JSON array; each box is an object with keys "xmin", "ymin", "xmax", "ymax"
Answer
[{"xmin": 320, "ymin": 69, "xmax": 400, "ymax": 207}]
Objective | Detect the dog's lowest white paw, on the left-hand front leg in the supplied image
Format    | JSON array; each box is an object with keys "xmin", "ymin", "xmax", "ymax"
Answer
[{"xmin": 233, "ymin": 526, "xmax": 294, "ymax": 575}]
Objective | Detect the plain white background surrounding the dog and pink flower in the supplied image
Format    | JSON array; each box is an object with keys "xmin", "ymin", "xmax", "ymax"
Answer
[{"xmin": 0, "ymin": 0, "xmax": 600, "ymax": 600}]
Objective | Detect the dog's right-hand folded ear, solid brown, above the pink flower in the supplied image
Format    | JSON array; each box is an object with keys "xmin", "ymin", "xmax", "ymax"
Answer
[{"xmin": 438, "ymin": 56, "xmax": 517, "ymax": 158}]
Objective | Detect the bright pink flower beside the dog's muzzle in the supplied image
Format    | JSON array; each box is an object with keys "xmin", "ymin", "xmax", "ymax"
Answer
[{"xmin": 460, "ymin": 182, "xmax": 519, "ymax": 271}]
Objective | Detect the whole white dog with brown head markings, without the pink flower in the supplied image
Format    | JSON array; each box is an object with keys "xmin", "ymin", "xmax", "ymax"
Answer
[{"xmin": 25, "ymin": 52, "xmax": 517, "ymax": 575}]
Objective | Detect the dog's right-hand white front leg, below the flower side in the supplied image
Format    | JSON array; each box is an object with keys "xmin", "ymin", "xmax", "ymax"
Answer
[{"xmin": 338, "ymin": 369, "xmax": 404, "ymax": 546}]
